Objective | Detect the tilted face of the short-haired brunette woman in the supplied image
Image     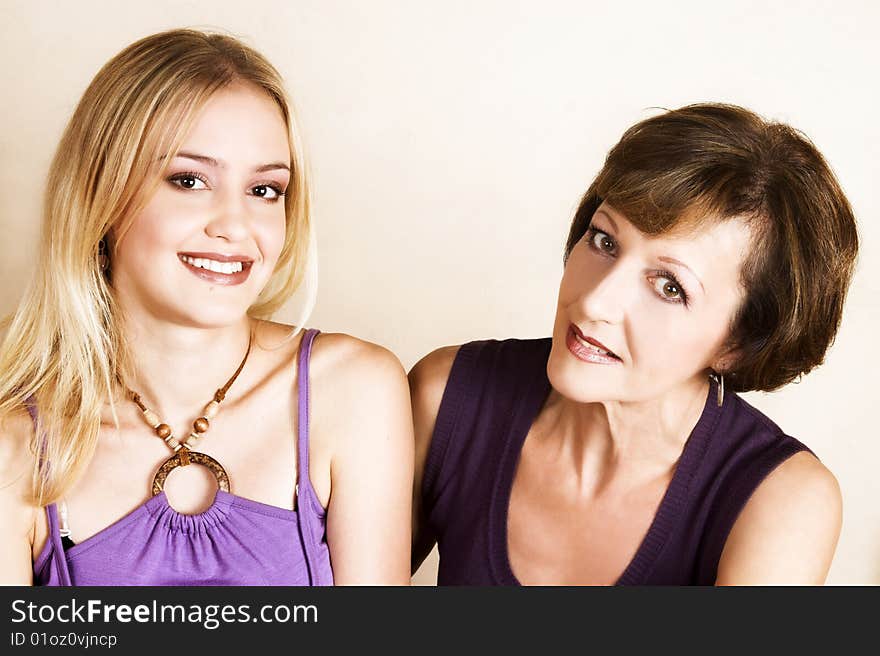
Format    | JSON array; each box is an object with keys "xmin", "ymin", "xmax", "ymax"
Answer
[{"xmin": 547, "ymin": 203, "xmax": 750, "ymax": 403}]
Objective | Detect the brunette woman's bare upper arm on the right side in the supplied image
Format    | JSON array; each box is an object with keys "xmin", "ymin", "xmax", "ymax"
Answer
[{"xmin": 715, "ymin": 452, "xmax": 842, "ymax": 585}]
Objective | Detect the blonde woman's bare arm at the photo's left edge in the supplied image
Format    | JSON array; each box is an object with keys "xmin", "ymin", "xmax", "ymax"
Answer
[{"xmin": 0, "ymin": 414, "xmax": 37, "ymax": 585}]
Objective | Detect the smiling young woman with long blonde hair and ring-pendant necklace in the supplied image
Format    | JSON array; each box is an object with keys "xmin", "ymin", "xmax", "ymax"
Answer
[{"xmin": 0, "ymin": 30, "xmax": 412, "ymax": 585}]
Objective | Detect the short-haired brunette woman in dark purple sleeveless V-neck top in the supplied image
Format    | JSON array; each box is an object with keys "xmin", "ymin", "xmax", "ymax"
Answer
[{"xmin": 410, "ymin": 104, "xmax": 858, "ymax": 585}]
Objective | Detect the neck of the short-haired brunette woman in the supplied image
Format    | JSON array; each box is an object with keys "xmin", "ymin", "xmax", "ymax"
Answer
[{"xmin": 540, "ymin": 377, "xmax": 709, "ymax": 488}]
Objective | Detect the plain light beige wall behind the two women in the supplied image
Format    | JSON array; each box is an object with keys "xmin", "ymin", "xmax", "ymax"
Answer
[{"xmin": 0, "ymin": 0, "xmax": 880, "ymax": 584}]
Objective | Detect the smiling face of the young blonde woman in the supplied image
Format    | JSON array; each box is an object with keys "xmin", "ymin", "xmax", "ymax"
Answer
[{"xmin": 111, "ymin": 84, "xmax": 290, "ymax": 327}]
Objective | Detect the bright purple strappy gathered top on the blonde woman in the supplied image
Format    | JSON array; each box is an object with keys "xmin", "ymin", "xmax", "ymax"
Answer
[{"xmin": 34, "ymin": 330, "xmax": 333, "ymax": 585}]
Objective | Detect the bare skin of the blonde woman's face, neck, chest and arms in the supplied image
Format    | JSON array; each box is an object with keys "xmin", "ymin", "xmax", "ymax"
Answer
[{"xmin": 0, "ymin": 84, "xmax": 413, "ymax": 585}]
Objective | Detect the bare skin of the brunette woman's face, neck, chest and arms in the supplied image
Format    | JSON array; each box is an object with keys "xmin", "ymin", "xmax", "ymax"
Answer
[{"xmin": 409, "ymin": 204, "xmax": 841, "ymax": 585}]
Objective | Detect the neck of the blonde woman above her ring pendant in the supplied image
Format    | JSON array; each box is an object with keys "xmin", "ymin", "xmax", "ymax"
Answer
[{"xmin": 117, "ymin": 308, "xmax": 251, "ymax": 426}]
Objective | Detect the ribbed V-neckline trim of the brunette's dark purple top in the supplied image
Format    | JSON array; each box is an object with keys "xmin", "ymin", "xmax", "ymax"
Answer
[{"xmin": 487, "ymin": 370, "xmax": 727, "ymax": 585}]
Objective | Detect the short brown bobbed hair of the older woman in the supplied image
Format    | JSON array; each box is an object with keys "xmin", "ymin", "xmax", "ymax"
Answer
[{"xmin": 565, "ymin": 103, "xmax": 858, "ymax": 392}]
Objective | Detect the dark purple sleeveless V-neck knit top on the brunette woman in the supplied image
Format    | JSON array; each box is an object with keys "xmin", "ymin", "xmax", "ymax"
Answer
[{"xmin": 422, "ymin": 338, "xmax": 808, "ymax": 585}]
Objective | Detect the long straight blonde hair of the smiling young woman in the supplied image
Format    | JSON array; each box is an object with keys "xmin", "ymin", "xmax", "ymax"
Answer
[{"xmin": 0, "ymin": 29, "xmax": 310, "ymax": 505}]
